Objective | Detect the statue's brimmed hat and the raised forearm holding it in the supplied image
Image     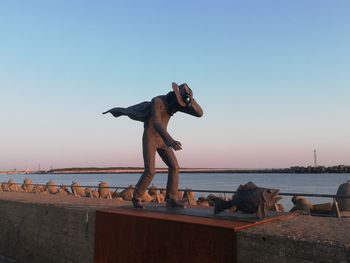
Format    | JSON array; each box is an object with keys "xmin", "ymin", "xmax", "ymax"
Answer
[{"xmin": 172, "ymin": 82, "xmax": 203, "ymax": 117}]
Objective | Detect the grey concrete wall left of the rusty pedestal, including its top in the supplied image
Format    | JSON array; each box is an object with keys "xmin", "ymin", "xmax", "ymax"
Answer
[{"xmin": 0, "ymin": 192, "xmax": 124, "ymax": 263}]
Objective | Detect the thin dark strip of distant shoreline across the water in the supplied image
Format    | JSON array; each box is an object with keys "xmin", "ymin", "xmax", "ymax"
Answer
[{"xmin": 0, "ymin": 165, "xmax": 350, "ymax": 174}]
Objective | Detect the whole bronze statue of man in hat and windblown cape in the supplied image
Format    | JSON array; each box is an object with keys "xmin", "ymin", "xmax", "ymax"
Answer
[{"xmin": 103, "ymin": 83, "xmax": 203, "ymax": 208}]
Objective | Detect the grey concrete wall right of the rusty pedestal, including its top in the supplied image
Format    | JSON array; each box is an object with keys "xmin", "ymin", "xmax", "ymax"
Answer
[{"xmin": 237, "ymin": 216, "xmax": 350, "ymax": 263}]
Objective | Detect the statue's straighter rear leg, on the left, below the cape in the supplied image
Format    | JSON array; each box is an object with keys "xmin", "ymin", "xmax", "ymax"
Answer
[{"xmin": 134, "ymin": 135, "xmax": 157, "ymax": 201}]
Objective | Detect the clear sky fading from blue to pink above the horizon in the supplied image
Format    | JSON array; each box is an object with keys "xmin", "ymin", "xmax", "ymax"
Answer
[{"xmin": 0, "ymin": 0, "xmax": 350, "ymax": 169}]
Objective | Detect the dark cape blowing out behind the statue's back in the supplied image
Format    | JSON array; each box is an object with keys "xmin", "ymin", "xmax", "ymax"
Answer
[{"xmin": 103, "ymin": 101, "xmax": 151, "ymax": 122}]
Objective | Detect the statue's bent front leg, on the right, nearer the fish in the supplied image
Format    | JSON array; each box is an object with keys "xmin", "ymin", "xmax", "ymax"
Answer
[{"xmin": 157, "ymin": 145, "xmax": 180, "ymax": 200}]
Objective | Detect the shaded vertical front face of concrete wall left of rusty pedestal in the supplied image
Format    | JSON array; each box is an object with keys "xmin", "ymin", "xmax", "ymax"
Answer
[{"xmin": 0, "ymin": 201, "xmax": 95, "ymax": 263}]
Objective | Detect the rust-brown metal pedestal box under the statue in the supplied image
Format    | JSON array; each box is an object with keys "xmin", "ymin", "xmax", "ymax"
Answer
[{"xmin": 94, "ymin": 207, "xmax": 296, "ymax": 263}]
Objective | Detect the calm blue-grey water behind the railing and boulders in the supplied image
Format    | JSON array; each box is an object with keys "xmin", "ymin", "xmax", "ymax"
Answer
[{"xmin": 0, "ymin": 173, "xmax": 350, "ymax": 209}]
